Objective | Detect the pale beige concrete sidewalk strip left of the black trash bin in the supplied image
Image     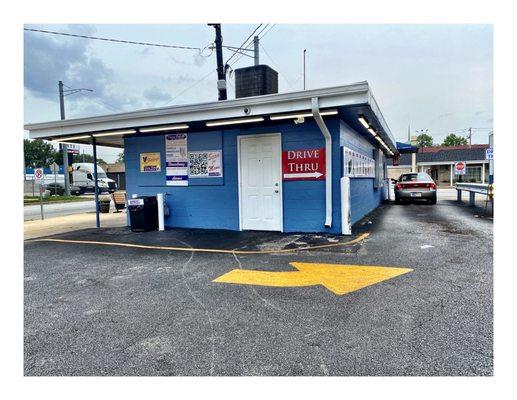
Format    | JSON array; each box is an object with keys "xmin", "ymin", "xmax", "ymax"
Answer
[{"xmin": 23, "ymin": 212, "xmax": 126, "ymax": 240}]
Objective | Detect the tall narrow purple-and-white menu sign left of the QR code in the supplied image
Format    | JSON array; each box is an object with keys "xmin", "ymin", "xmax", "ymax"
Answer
[{"xmin": 165, "ymin": 133, "xmax": 188, "ymax": 186}]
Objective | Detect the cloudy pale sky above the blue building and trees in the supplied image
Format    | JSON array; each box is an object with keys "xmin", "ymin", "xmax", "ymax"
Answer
[{"xmin": 24, "ymin": 24, "xmax": 493, "ymax": 162}]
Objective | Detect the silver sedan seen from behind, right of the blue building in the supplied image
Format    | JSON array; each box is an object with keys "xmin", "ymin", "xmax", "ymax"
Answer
[{"xmin": 395, "ymin": 172, "xmax": 436, "ymax": 204}]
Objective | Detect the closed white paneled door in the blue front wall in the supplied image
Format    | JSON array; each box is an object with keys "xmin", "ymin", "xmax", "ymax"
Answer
[{"xmin": 239, "ymin": 134, "xmax": 282, "ymax": 231}]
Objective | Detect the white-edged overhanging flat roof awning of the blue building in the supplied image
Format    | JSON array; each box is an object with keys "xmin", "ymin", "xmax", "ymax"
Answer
[{"xmin": 24, "ymin": 82, "xmax": 397, "ymax": 152}]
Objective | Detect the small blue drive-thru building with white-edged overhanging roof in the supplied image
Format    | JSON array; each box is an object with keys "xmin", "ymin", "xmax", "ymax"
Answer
[{"xmin": 26, "ymin": 82, "xmax": 397, "ymax": 234}]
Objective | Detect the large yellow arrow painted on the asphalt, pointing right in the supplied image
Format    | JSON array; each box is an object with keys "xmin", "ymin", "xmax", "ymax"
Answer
[{"xmin": 213, "ymin": 262, "xmax": 413, "ymax": 295}]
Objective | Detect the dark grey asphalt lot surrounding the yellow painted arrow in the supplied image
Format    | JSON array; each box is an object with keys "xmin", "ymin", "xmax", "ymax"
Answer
[{"xmin": 24, "ymin": 200, "xmax": 493, "ymax": 376}]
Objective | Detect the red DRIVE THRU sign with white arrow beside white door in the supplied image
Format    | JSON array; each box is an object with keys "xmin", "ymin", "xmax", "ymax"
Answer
[{"xmin": 282, "ymin": 147, "xmax": 325, "ymax": 181}]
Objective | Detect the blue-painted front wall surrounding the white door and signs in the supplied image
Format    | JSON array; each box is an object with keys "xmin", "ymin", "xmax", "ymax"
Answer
[{"xmin": 125, "ymin": 118, "xmax": 342, "ymax": 233}]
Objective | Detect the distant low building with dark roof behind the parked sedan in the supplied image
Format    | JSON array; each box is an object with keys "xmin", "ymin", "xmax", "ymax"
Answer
[{"xmin": 388, "ymin": 144, "xmax": 489, "ymax": 186}]
